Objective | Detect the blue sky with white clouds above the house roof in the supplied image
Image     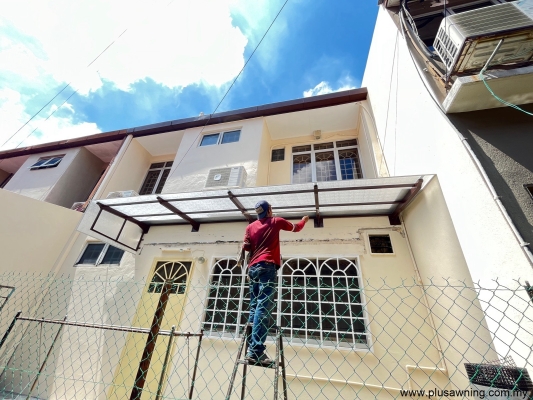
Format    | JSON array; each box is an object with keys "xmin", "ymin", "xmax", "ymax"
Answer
[{"xmin": 0, "ymin": 0, "xmax": 378, "ymax": 150}]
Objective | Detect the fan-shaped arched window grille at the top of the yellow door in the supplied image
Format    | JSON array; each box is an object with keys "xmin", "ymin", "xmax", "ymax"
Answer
[{"xmin": 148, "ymin": 261, "xmax": 192, "ymax": 294}]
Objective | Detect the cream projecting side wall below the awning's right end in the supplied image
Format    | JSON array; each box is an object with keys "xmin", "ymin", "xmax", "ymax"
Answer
[{"xmin": 403, "ymin": 176, "xmax": 498, "ymax": 389}]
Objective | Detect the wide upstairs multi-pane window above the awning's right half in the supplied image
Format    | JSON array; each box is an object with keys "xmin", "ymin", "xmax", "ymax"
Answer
[{"xmin": 292, "ymin": 139, "xmax": 363, "ymax": 183}]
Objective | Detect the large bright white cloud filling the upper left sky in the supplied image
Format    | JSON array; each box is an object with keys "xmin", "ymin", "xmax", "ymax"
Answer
[{"xmin": 0, "ymin": 0, "xmax": 284, "ymax": 149}]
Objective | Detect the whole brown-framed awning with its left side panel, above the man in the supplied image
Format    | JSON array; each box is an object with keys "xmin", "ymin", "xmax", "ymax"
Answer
[{"xmin": 78, "ymin": 176, "xmax": 423, "ymax": 252}]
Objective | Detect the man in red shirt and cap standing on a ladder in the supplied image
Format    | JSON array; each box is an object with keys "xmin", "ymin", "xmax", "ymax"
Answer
[{"xmin": 243, "ymin": 200, "xmax": 309, "ymax": 364}]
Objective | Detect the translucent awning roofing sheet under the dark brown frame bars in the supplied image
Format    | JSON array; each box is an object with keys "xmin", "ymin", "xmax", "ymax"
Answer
[{"xmin": 93, "ymin": 176, "xmax": 420, "ymax": 225}]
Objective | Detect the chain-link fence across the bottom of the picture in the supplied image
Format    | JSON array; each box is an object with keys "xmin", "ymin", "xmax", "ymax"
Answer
[{"xmin": 0, "ymin": 270, "xmax": 533, "ymax": 399}]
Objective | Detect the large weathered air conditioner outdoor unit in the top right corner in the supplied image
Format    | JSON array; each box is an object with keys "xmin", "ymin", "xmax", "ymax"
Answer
[{"xmin": 433, "ymin": 0, "xmax": 533, "ymax": 77}]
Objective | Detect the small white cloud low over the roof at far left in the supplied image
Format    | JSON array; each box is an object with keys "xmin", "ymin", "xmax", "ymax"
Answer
[{"xmin": 0, "ymin": 89, "xmax": 101, "ymax": 150}]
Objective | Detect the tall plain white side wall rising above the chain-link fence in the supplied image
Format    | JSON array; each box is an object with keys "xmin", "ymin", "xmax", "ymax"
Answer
[{"xmin": 362, "ymin": 7, "xmax": 533, "ymax": 282}]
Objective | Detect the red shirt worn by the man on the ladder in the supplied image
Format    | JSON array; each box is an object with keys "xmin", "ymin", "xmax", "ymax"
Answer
[{"xmin": 242, "ymin": 217, "xmax": 305, "ymax": 266}]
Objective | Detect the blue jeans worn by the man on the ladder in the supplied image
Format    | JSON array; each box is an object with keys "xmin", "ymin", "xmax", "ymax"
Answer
[{"xmin": 247, "ymin": 262, "xmax": 277, "ymax": 358}]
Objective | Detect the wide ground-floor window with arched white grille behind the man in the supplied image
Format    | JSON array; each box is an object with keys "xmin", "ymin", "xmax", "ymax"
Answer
[{"xmin": 204, "ymin": 258, "xmax": 369, "ymax": 348}]
